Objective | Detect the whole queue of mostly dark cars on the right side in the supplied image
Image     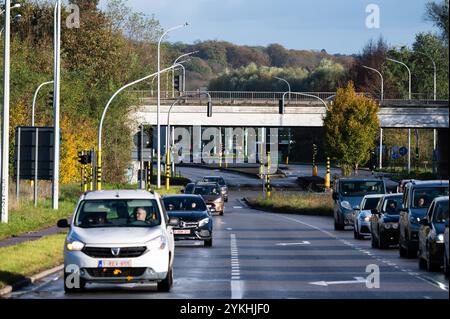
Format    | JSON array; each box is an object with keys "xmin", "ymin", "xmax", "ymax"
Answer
[{"xmin": 333, "ymin": 178, "xmax": 449, "ymax": 275}]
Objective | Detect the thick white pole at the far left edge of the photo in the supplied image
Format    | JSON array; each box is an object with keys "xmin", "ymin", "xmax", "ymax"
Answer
[{"xmin": 1, "ymin": 0, "xmax": 11, "ymax": 224}]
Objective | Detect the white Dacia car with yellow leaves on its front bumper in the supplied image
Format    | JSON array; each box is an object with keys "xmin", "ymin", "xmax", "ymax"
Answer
[{"xmin": 58, "ymin": 190, "xmax": 179, "ymax": 293}]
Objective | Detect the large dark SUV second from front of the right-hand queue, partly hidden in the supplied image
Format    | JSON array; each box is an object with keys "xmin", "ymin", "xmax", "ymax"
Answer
[{"xmin": 399, "ymin": 180, "xmax": 448, "ymax": 258}]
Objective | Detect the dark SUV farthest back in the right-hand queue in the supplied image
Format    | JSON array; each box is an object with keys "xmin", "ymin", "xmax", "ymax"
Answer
[{"xmin": 333, "ymin": 178, "xmax": 386, "ymax": 230}]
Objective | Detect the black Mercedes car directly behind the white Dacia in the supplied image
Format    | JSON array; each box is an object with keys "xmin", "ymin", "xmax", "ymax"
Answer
[{"xmin": 163, "ymin": 194, "xmax": 213, "ymax": 247}]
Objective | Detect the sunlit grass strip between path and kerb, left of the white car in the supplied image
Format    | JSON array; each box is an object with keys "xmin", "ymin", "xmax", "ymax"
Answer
[{"xmin": 0, "ymin": 234, "xmax": 66, "ymax": 289}]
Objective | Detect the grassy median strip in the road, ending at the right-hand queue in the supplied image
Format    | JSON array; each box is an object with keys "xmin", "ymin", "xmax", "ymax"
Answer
[{"xmin": 248, "ymin": 192, "xmax": 333, "ymax": 216}]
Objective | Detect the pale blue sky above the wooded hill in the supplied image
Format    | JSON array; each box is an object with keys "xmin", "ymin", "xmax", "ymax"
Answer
[{"xmin": 100, "ymin": 0, "xmax": 435, "ymax": 54}]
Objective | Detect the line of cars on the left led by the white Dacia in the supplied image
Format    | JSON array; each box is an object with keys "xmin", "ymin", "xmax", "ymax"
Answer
[{"xmin": 58, "ymin": 177, "xmax": 228, "ymax": 293}]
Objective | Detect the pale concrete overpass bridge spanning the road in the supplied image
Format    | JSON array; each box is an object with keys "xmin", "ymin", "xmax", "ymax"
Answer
[{"xmin": 133, "ymin": 92, "xmax": 449, "ymax": 129}]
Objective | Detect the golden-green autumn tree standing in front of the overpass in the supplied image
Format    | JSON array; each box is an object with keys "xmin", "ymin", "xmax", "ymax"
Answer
[{"xmin": 324, "ymin": 82, "xmax": 380, "ymax": 175}]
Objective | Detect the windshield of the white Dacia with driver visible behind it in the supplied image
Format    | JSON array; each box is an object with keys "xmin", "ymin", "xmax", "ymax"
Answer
[{"xmin": 75, "ymin": 199, "xmax": 161, "ymax": 228}]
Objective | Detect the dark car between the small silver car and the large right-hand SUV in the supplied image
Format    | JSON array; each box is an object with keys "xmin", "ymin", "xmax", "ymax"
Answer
[{"xmin": 370, "ymin": 194, "xmax": 403, "ymax": 249}]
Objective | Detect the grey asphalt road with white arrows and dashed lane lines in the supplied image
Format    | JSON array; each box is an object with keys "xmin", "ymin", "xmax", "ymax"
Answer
[{"xmin": 11, "ymin": 191, "xmax": 448, "ymax": 300}]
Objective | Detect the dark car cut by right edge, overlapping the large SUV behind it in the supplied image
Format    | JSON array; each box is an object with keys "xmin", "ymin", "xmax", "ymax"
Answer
[{"xmin": 419, "ymin": 196, "xmax": 448, "ymax": 271}]
